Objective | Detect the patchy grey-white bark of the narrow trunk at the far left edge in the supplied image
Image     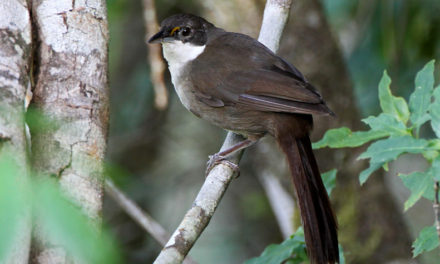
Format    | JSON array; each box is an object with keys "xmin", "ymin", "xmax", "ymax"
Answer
[{"xmin": 0, "ymin": 0, "xmax": 32, "ymax": 264}]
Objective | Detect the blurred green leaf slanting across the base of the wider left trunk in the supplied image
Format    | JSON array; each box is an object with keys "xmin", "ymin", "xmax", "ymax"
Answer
[{"xmin": 34, "ymin": 178, "xmax": 121, "ymax": 263}]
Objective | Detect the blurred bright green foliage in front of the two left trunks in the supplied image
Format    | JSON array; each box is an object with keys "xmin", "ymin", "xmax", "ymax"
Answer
[{"xmin": 0, "ymin": 150, "xmax": 121, "ymax": 263}]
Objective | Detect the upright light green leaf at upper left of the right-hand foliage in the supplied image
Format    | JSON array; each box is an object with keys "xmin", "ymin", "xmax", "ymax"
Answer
[{"xmin": 379, "ymin": 71, "xmax": 409, "ymax": 124}]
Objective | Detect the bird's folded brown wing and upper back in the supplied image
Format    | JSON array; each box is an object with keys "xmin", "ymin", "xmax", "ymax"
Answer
[{"xmin": 191, "ymin": 33, "xmax": 332, "ymax": 114}]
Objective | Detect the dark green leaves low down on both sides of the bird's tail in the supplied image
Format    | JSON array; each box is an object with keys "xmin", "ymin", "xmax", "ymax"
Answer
[{"xmin": 244, "ymin": 170, "xmax": 345, "ymax": 264}]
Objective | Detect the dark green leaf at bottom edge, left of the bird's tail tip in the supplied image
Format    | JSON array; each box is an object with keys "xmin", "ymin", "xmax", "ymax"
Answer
[{"xmin": 244, "ymin": 228, "xmax": 307, "ymax": 264}]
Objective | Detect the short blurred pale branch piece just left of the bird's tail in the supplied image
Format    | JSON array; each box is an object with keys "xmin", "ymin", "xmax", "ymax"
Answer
[{"xmin": 257, "ymin": 170, "xmax": 295, "ymax": 239}]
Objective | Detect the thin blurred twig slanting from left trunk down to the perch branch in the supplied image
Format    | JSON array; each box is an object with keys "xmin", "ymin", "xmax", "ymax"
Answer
[{"xmin": 105, "ymin": 179, "xmax": 196, "ymax": 264}]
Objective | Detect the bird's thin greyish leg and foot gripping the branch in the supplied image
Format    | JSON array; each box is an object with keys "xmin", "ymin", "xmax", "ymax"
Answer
[{"xmin": 205, "ymin": 138, "xmax": 258, "ymax": 177}]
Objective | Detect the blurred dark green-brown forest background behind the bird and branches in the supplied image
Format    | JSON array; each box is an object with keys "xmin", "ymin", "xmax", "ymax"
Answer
[{"xmin": 104, "ymin": 0, "xmax": 440, "ymax": 264}]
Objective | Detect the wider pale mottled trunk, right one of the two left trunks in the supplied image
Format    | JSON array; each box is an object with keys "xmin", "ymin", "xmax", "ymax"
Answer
[{"xmin": 31, "ymin": 0, "xmax": 108, "ymax": 263}]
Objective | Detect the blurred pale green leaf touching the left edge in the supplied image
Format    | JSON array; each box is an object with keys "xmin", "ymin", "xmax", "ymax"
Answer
[{"xmin": 0, "ymin": 155, "xmax": 30, "ymax": 262}]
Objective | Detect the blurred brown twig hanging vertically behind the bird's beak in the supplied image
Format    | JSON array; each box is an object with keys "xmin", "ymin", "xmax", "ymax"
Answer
[{"xmin": 142, "ymin": 0, "xmax": 168, "ymax": 110}]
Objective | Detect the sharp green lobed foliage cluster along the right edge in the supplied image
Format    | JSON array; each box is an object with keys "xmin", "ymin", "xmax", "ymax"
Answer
[{"xmin": 314, "ymin": 60, "xmax": 440, "ymax": 257}]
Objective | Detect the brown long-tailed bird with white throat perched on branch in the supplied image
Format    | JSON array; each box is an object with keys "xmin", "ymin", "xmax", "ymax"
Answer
[{"xmin": 148, "ymin": 14, "xmax": 339, "ymax": 264}]
